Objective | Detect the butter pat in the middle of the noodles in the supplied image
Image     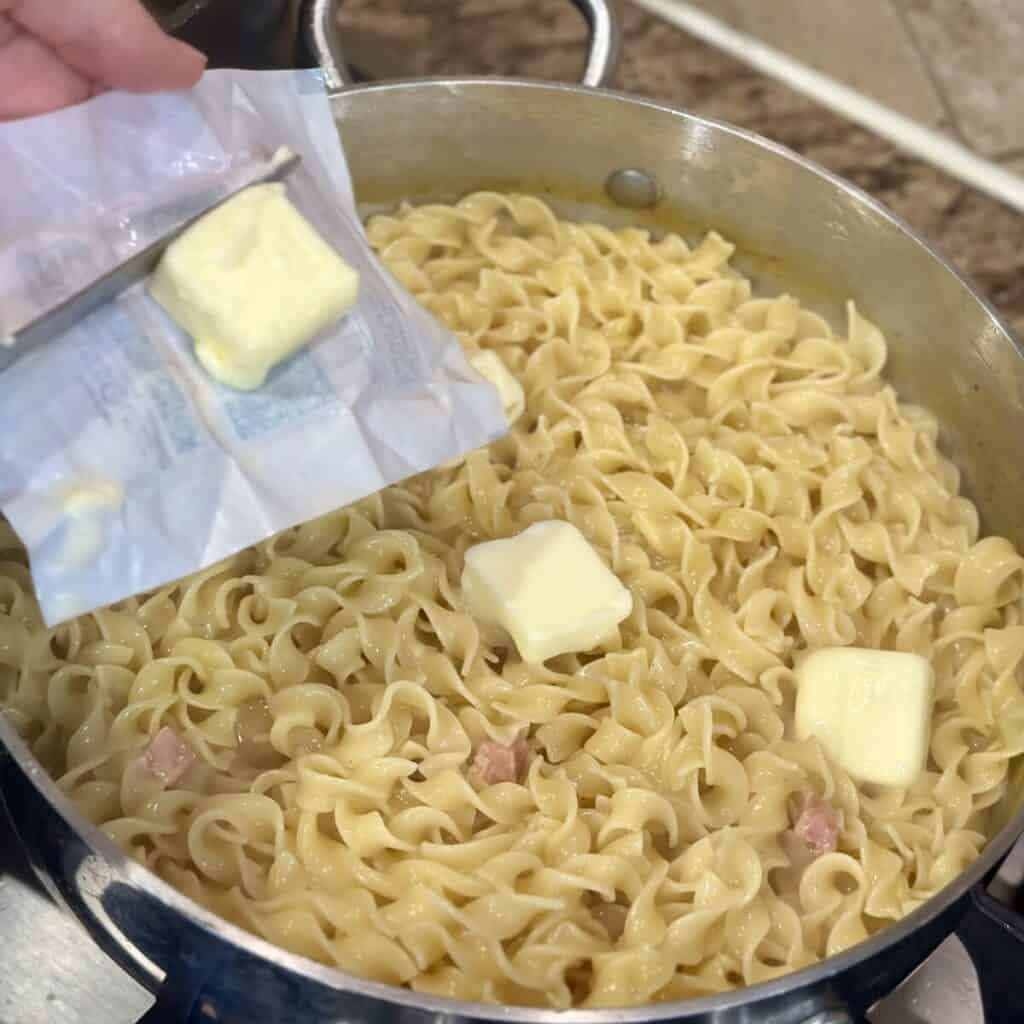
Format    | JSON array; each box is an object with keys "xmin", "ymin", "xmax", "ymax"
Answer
[{"xmin": 462, "ymin": 521, "xmax": 633, "ymax": 662}]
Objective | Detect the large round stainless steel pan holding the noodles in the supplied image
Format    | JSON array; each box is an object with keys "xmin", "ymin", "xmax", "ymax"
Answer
[{"xmin": 0, "ymin": 0, "xmax": 1024, "ymax": 1024}]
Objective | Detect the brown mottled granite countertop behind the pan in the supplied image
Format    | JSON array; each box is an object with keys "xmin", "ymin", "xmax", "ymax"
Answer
[{"xmin": 342, "ymin": 0, "xmax": 1024, "ymax": 336}]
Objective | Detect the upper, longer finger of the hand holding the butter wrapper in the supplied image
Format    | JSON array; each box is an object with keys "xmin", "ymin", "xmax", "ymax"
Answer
[{"xmin": 8, "ymin": 0, "xmax": 206, "ymax": 92}]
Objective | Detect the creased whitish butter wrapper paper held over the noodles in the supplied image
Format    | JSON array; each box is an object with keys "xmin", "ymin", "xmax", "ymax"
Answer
[{"xmin": 0, "ymin": 71, "xmax": 508, "ymax": 625}]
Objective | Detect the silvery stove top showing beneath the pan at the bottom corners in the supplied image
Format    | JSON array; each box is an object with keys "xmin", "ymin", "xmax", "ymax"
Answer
[{"xmin": 0, "ymin": 786, "xmax": 1024, "ymax": 1024}]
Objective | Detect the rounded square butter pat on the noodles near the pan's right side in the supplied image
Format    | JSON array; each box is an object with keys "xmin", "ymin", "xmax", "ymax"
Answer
[{"xmin": 796, "ymin": 647, "xmax": 935, "ymax": 786}]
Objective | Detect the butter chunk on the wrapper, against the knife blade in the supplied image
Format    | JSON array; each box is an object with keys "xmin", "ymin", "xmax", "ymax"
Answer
[{"xmin": 150, "ymin": 183, "xmax": 359, "ymax": 390}]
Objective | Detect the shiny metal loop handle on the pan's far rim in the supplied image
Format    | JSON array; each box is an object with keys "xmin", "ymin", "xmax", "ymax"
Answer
[{"xmin": 304, "ymin": 0, "xmax": 622, "ymax": 92}]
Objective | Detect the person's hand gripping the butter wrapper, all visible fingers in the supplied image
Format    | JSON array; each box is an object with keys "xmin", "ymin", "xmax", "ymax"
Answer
[{"xmin": 0, "ymin": 0, "xmax": 206, "ymax": 121}]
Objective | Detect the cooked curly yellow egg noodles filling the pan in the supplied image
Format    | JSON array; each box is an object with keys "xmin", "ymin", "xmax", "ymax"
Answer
[{"xmin": 0, "ymin": 194, "xmax": 1024, "ymax": 1008}]
